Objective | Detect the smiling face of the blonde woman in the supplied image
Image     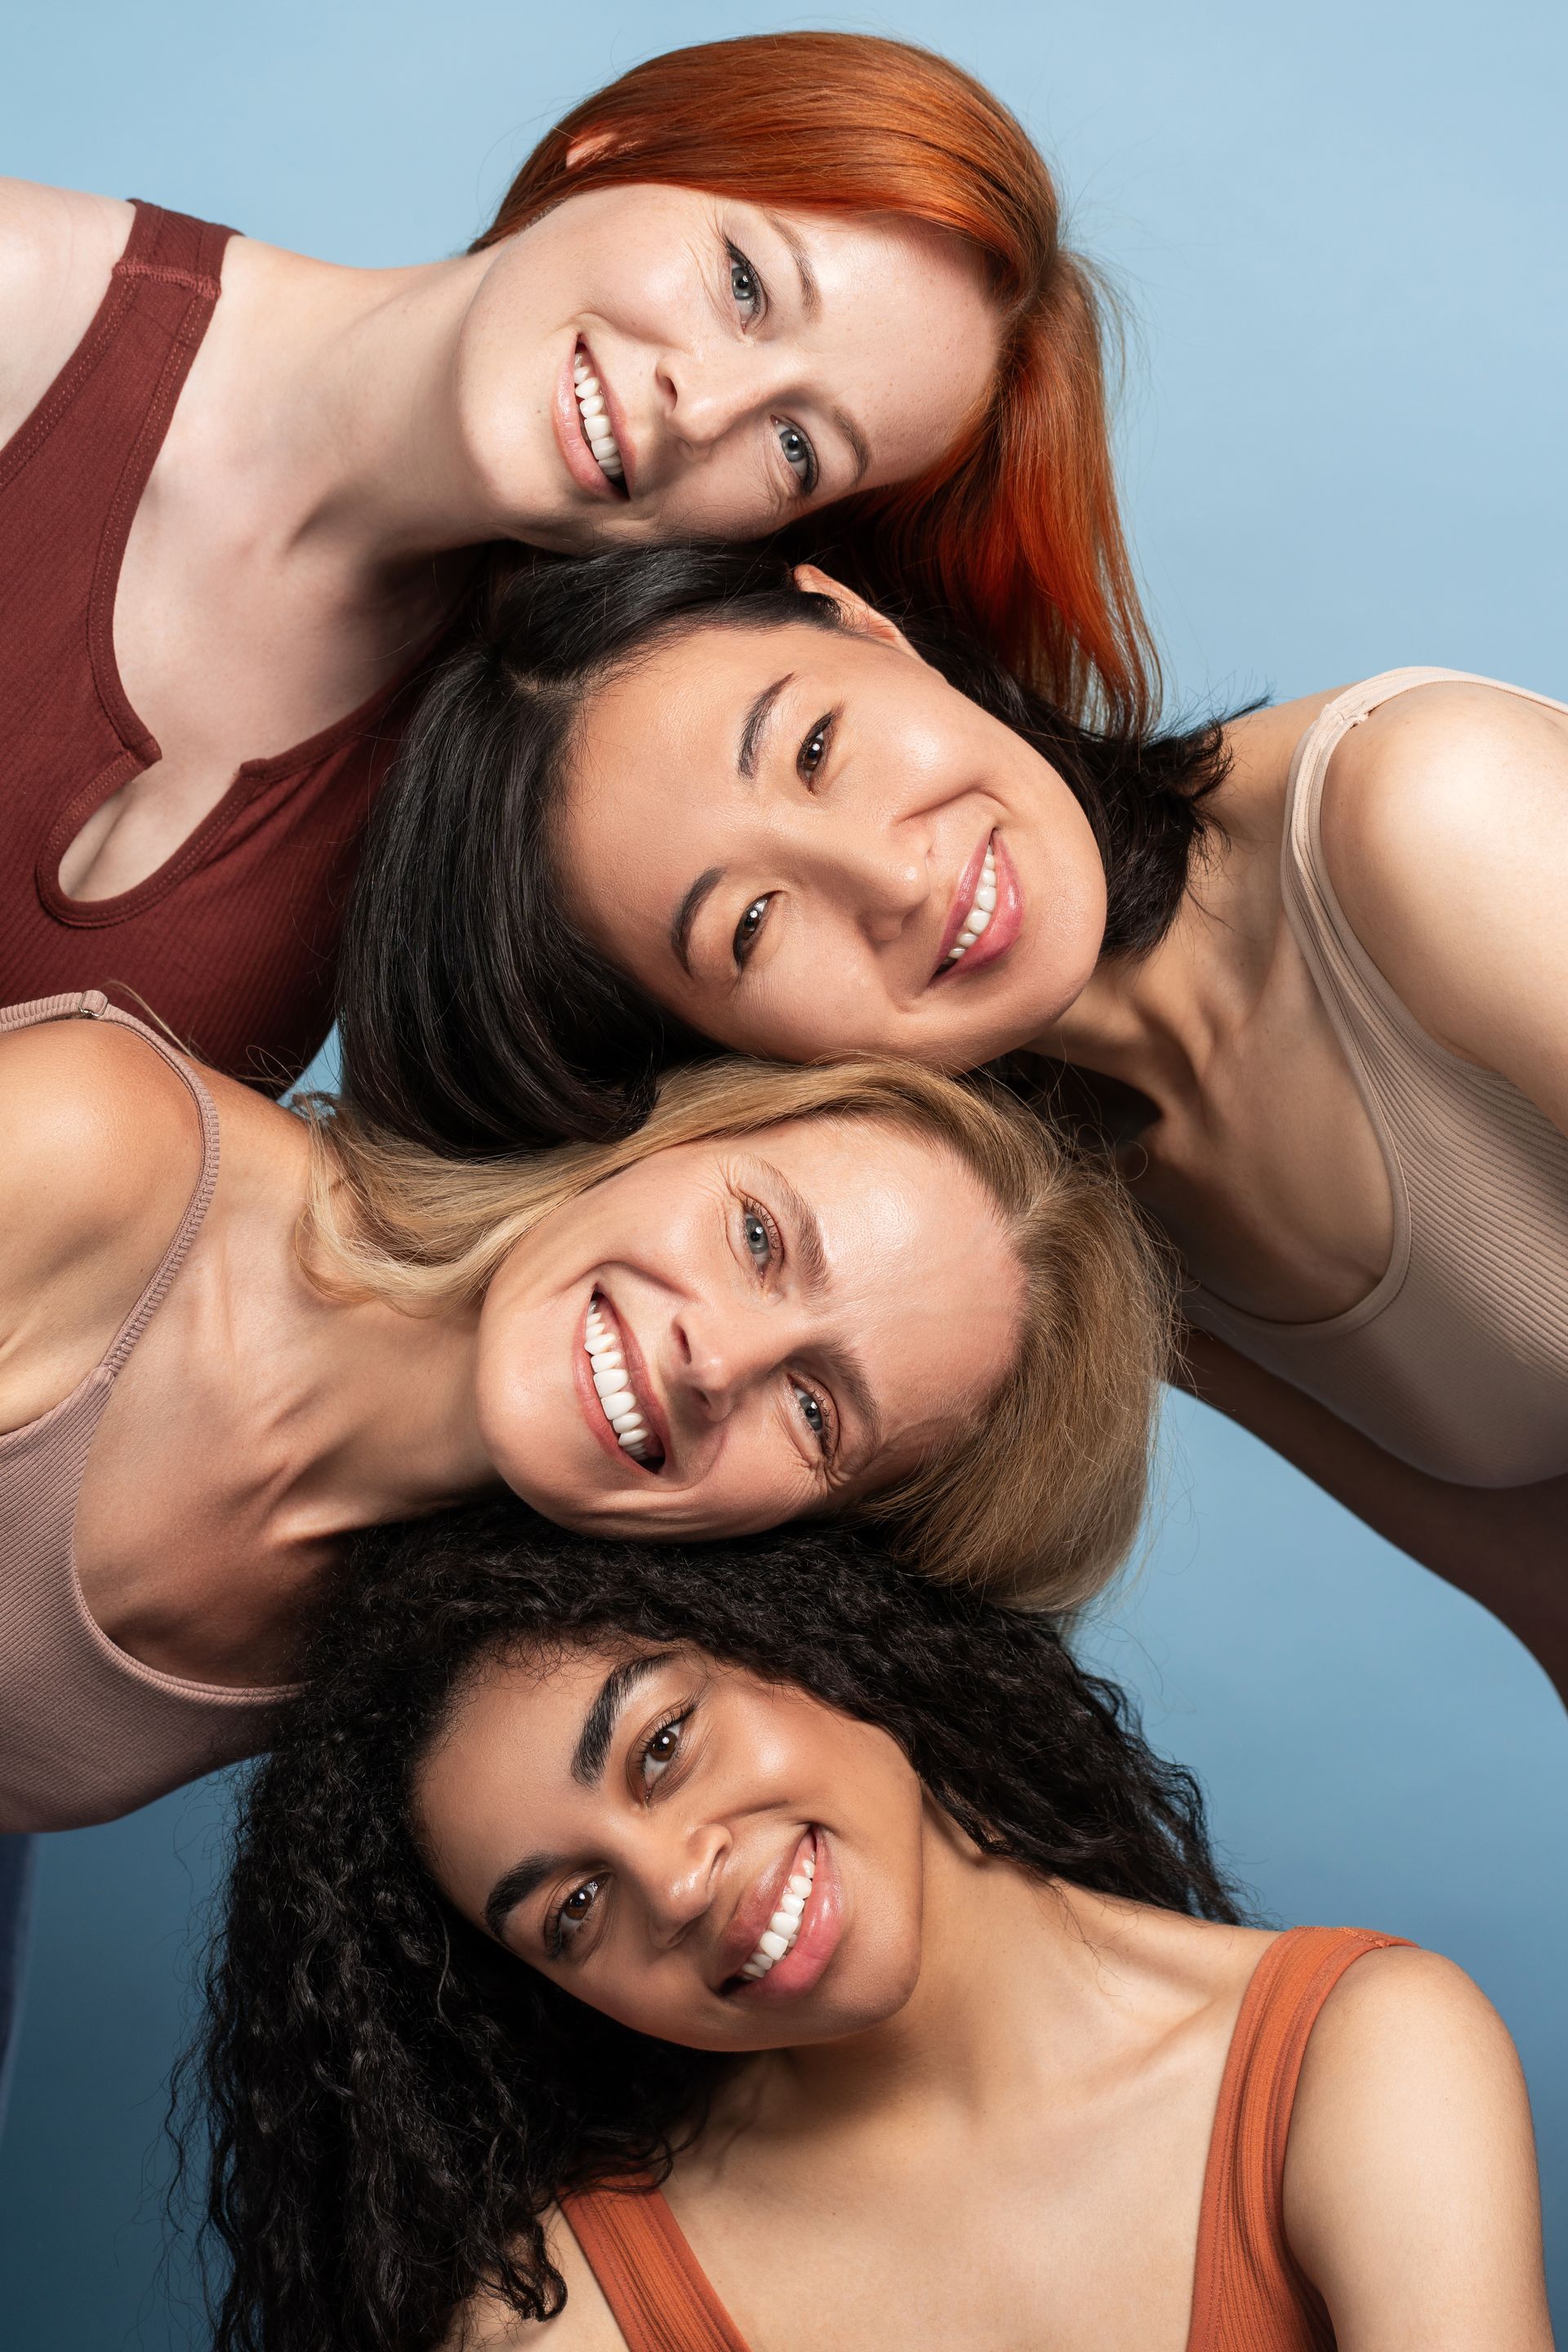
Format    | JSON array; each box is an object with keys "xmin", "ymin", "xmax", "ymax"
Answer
[{"xmin": 477, "ymin": 1117, "xmax": 1020, "ymax": 1539}]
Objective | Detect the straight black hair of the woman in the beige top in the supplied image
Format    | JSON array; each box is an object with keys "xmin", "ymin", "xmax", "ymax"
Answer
[{"xmin": 339, "ymin": 546, "xmax": 1225, "ymax": 1157}]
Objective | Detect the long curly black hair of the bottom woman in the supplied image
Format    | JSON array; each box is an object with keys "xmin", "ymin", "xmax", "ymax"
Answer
[{"xmin": 176, "ymin": 1503, "xmax": 1239, "ymax": 2352}]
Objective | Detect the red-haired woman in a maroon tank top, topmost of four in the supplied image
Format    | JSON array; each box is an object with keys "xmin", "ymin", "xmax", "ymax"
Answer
[{"xmin": 0, "ymin": 33, "xmax": 1150, "ymax": 1089}]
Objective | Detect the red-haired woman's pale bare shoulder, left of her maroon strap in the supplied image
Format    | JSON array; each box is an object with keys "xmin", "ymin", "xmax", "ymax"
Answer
[{"xmin": 0, "ymin": 179, "xmax": 131, "ymax": 442}]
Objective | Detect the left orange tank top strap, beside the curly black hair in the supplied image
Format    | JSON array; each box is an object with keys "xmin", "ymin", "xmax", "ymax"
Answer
[{"xmin": 559, "ymin": 2178, "xmax": 747, "ymax": 2352}]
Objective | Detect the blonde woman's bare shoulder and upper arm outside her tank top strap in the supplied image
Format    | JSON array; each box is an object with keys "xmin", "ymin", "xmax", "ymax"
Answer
[{"xmin": 0, "ymin": 1021, "xmax": 203, "ymax": 1430}]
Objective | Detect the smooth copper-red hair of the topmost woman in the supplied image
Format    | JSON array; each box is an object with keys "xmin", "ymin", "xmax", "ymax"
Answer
[{"xmin": 474, "ymin": 33, "xmax": 1159, "ymax": 727}]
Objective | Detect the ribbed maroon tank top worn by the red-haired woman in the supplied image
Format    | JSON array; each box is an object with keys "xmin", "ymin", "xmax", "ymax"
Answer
[{"xmin": 0, "ymin": 205, "xmax": 430, "ymax": 1091}]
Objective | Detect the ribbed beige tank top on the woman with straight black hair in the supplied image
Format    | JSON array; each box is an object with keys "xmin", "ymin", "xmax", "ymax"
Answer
[{"xmin": 1185, "ymin": 670, "xmax": 1568, "ymax": 1486}]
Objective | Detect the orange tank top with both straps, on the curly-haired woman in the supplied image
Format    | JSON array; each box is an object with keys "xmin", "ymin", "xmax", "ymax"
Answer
[{"xmin": 559, "ymin": 1927, "xmax": 1404, "ymax": 2352}]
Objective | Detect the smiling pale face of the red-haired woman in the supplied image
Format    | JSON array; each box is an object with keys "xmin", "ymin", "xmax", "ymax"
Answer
[{"xmin": 454, "ymin": 186, "xmax": 999, "ymax": 553}]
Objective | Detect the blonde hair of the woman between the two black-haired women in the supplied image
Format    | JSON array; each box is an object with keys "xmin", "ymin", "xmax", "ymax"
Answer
[{"xmin": 301, "ymin": 1056, "xmax": 1171, "ymax": 1609}]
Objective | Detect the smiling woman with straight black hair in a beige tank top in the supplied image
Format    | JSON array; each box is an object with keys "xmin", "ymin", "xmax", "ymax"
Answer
[{"xmin": 343, "ymin": 550, "xmax": 1568, "ymax": 1689}]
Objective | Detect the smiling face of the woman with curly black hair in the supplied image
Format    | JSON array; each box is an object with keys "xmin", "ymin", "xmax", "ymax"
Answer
[{"xmin": 416, "ymin": 1649, "xmax": 929, "ymax": 2051}]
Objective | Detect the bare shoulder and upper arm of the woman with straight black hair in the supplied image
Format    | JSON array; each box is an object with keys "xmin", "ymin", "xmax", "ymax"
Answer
[{"xmin": 1321, "ymin": 682, "xmax": 1568, "ymax": 1131}]
